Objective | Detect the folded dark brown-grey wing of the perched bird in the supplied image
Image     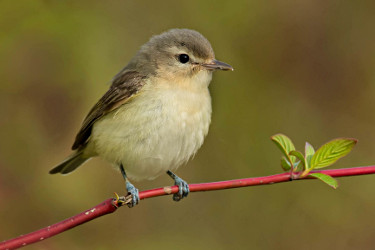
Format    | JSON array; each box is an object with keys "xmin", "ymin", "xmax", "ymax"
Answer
[{"xmin": 72, "ymin": 71, "xmax": 145, "ymax": 150}]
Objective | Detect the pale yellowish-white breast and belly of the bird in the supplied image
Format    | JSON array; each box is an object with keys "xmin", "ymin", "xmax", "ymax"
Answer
[{"xmin": 88, "ymin": 84, "xmax": 211, "ymax": 180}]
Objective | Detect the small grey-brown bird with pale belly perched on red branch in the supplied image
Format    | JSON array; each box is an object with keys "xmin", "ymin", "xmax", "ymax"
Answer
[{"xmin": 49, "ymin": 28, "xmax": 233, "ymax": 207}]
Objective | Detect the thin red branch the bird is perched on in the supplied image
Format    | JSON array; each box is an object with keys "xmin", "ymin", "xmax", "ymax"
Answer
[{"xmin": 0, "ymin": 166, "xmax": 375, "ymax": 250}]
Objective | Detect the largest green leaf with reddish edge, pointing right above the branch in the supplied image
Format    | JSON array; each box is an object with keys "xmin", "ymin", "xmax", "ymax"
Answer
[{"xmin": 310, "ymin": 138, "xmax": 357, "ymax": 169}]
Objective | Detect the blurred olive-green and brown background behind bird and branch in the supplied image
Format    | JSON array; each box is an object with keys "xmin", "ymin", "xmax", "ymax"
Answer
[{"xmin": 0, "ymin": 0, "xmax": 375, "ymax": 249}]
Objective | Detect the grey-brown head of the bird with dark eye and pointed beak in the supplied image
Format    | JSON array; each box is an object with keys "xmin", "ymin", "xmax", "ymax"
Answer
[{"xmin": 128, "ymin": 29, "xmax": 233, "ymax": 84}]
